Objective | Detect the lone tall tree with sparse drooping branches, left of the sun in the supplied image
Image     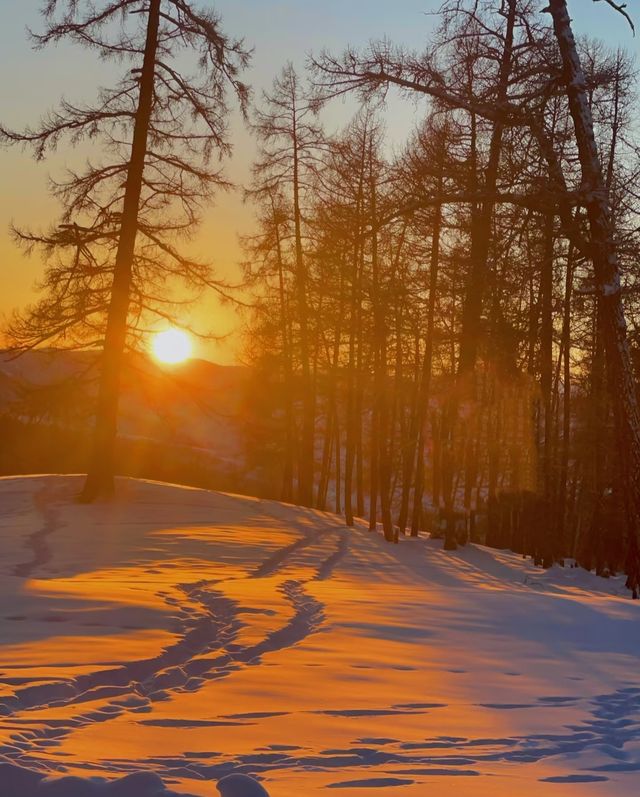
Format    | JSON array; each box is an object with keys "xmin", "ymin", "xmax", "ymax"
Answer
[{"xmin": 0, "ymin": 0, "xmax": 249, "ymax": 501}]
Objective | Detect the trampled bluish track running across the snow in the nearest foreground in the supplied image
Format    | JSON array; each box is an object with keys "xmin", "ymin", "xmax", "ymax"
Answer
[{"xmin": 81, "ymin": 686, "xmax": 640, "ymax": 788}]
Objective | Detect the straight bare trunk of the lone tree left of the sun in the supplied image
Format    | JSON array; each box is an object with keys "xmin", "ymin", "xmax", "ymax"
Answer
[{"xmin": 80, "ymin": 0, "xmax": 160, "ymax": 502}]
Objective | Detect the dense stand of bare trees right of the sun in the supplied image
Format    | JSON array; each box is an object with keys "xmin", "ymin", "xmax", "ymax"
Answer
[{"xmin": 245, "ymin": 0, "xmax": 640, "ymax": 595}]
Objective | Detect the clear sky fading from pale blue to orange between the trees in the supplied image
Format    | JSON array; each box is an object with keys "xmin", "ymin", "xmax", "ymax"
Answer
[{"xmin": 0, "ymin": 0, "xmax": 640, "ymax": 363}]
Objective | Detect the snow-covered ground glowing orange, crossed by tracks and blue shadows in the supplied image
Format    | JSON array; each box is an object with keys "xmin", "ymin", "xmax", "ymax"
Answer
[{"xmin": 0, "ymin": 476, "xmax": 640, "ymax": 797}]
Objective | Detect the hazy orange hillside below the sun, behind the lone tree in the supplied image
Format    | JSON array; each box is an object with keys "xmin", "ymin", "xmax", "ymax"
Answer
[{"xmin": 0, "ymin": 349, "xmax": 247, "ymax": 484}]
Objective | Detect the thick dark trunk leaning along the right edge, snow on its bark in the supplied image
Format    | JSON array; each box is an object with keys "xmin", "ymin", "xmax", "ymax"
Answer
[{"xmin": 548, "ymin": 0, "xmax": 640, "ymax": 598}]
